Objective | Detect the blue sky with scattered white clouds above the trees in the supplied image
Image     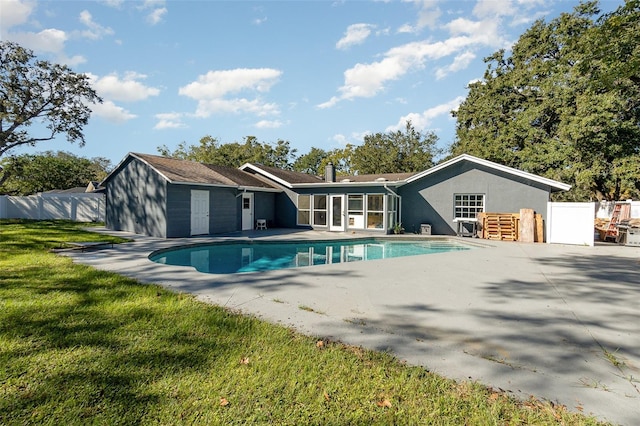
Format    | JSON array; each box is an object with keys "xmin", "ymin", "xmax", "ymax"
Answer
[{"xmin": 0, "ymin": 0, "xmax": 623, "ymax": 165}]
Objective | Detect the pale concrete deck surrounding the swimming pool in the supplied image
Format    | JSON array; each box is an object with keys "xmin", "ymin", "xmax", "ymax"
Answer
[{"xmin": 64, "ymin": 228, "xmax": 640, "ymax": 425}]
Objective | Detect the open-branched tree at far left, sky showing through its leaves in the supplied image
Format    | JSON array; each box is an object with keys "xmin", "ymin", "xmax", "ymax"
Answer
[{"xmin": 0, "ymin": 41, "xmax": 102, "ymax": 157}]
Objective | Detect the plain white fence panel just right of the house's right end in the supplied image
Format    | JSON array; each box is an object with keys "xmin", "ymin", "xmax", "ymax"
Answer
[{"xmin": 547, "ymin": 203, "xmax": 596, "ymax": 246}]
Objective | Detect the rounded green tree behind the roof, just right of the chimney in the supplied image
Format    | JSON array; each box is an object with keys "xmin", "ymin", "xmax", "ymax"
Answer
[{"xmin": 351, "ymin": 121, "xmax": 439, "ymax": 174}]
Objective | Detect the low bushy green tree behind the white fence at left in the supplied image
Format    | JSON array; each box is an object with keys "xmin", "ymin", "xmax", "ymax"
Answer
[{"xmin": 0, "ymin": 151, "xmax": 111, "ymax": 195}]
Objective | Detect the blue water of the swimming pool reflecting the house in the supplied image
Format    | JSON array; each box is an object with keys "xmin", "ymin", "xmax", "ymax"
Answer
[{"xmin": 149, "ymin": 238, "xmax": 475, "ymax": 274}]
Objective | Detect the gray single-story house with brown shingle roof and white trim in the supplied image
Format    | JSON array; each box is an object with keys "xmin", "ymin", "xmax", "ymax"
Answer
[{"xmin": 101, "ymin": 153, "xmax": 570, "ymax": 238}]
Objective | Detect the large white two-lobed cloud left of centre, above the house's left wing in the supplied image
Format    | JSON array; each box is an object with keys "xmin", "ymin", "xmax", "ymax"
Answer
[{"xmin": 178, "ymin": 68, "xmax": 282, "ymax": 117}]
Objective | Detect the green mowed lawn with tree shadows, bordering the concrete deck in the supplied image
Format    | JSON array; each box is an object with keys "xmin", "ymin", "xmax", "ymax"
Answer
[{"xmin": 0, "ymin": 220, "xmax": 597, "ymax": 425}]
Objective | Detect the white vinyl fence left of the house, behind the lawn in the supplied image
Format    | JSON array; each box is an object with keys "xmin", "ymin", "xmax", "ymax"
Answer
[{"xmin": 0, "ymin": 192, "xmax": 105, "ymax": 222}]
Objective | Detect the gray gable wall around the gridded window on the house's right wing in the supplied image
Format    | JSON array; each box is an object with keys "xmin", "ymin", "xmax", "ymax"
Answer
[{"xmin": 399, "ymin": 162, "xmax": 550, "ymax": 235}]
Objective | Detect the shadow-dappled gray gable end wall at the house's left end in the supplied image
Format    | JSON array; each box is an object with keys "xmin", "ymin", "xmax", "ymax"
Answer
[{"xmin": 105, "ymin": 159, "xmax": 167, "ymax": 238}]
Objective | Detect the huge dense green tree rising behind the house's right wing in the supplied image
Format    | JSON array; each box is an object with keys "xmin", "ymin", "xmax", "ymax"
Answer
[{"xmin": 451, "ymin": 2, "xmax": 640, "ymax": 201}]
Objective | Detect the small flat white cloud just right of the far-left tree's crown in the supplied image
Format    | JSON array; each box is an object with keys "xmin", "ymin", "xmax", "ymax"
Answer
[{"xmin": 89, "ymin": 72, "xmax": 160, "ymax": 102}]
